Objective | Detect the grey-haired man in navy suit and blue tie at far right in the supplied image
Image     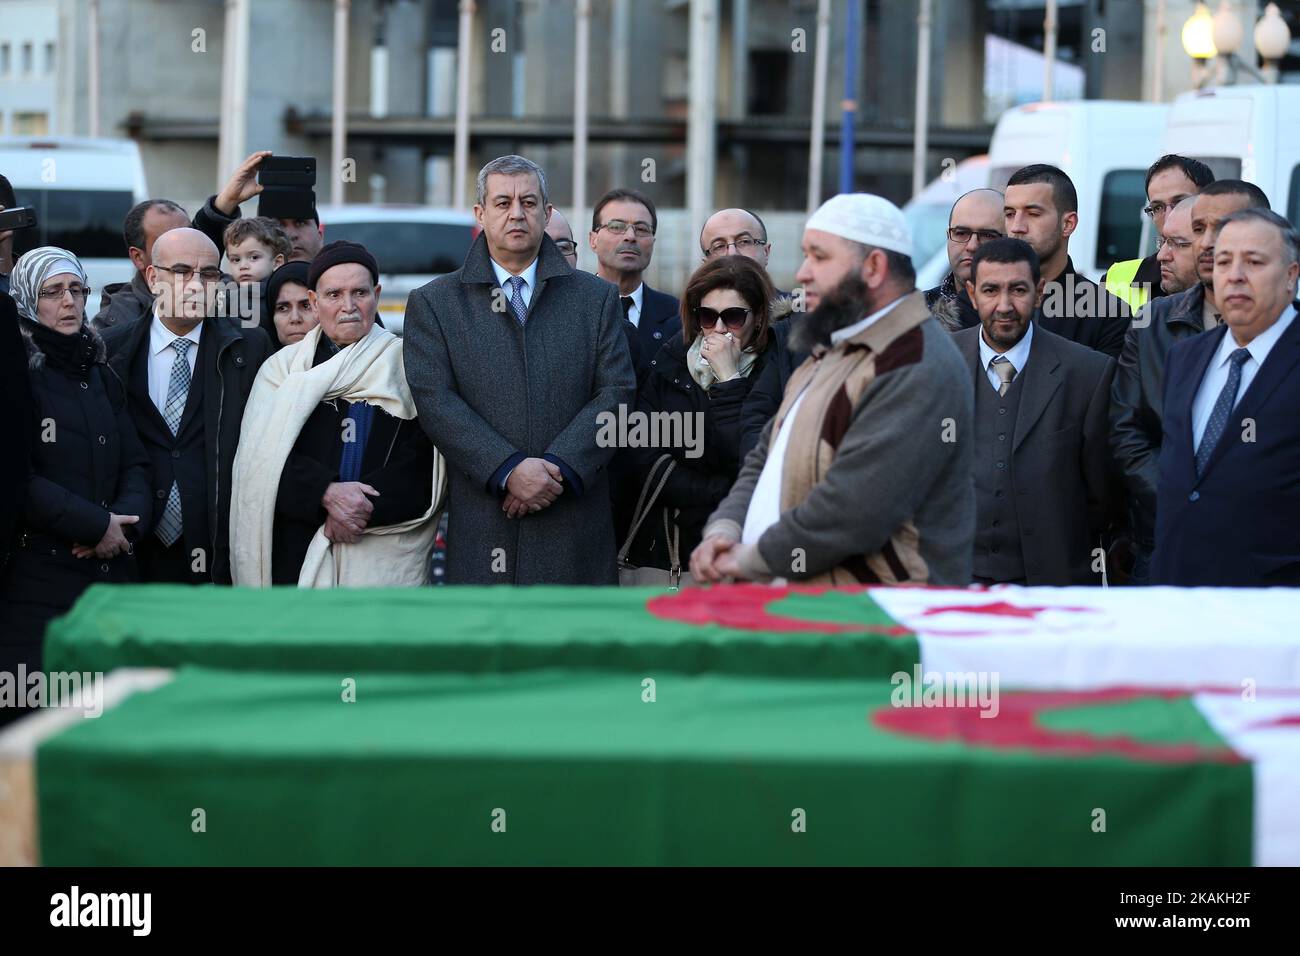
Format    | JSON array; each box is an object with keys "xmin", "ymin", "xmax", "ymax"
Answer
[{"xmin": 1152, "ymin": 208, "xmax": 1300, "ymax": 587}]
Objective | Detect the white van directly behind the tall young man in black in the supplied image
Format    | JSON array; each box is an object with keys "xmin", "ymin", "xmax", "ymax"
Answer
[{"xmin": 988, "ymin": 100, "xmax": 1170, "ymax": 280}]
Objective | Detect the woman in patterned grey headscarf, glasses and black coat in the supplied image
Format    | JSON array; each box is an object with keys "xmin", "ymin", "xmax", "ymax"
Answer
[{"xmin": 0, "ymin": 246, "xmax": 152, "ymax": 697}]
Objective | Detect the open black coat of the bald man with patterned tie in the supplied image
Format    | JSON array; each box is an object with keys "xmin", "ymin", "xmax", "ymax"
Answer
[{"xmin": 104, "ymin": 319, "xmax": 270, "ymax": 584}]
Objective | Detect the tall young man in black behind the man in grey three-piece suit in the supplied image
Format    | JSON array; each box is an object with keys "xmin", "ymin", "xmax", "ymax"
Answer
[{"xmin": 1005, "ymin": 164, "xmax": 1130, "ymax": 356}]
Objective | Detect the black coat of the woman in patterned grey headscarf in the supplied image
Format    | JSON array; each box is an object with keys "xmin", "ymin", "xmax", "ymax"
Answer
[{"xmin": 0, "ymin": 317, "xmax": 152, "ymax": 660}]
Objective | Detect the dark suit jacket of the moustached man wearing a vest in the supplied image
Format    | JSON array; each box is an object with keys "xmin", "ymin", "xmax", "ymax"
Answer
[{"xmin": 953, "ymin": 326, "xmax": 1117, "ymax": 585}]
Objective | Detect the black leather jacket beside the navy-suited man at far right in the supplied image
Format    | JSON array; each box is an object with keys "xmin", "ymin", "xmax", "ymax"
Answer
[{"xmin": 1110, "ymin": 282, "xmax": 1205, "ymax": 551}]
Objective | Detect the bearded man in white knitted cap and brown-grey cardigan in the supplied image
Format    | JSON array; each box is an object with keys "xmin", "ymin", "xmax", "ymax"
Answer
[{"xmin": 690, "ymin": 193, "xmax": 975, "ymax": 585}]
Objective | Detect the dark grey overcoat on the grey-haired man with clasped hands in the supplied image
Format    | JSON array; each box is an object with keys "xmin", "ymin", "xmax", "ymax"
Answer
[{"xmin": 403, "ymin": 235, "xmax": 636, "ymax": 584}]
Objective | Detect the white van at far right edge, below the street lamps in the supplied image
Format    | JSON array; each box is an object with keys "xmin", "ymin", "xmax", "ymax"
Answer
[{"xmin": 1164, "ymin": 86, "xmax": 1300, "ymax": 224}]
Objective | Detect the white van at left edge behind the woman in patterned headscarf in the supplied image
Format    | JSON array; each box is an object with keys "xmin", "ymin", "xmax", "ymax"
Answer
[{"xmin": 0, "ymin": 137, "xmax": 148, "ymax": 297}]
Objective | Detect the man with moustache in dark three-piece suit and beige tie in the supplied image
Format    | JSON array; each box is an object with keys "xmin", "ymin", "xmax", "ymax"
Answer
[{"xmin": 953, "ymin": 239, "xmax": 1115, "ymax": 585}]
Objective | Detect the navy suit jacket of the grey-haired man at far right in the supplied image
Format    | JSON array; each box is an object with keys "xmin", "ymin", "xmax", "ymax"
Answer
[{"xmin": 1151, "ymin": 303, "xmax": 1300, "ymax": 587}]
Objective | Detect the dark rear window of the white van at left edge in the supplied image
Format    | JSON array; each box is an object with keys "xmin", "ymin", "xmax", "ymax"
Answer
[{"xmin": 13, "ymin": 186, "xmax": 135, "ymax": 259}]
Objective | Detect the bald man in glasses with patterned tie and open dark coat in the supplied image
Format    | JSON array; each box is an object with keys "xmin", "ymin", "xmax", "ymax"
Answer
[{"xmin": 104, "ymin": 228, "xmax": 270, "ymax": 584}]
